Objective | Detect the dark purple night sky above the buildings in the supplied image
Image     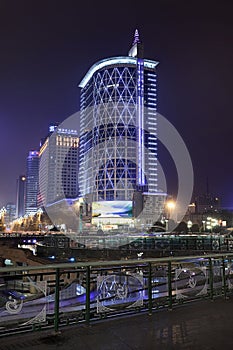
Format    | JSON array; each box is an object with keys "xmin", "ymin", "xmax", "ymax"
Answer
[{"xmin": 0, "ymin": 0, "xmax": 233, "ymax": 207}]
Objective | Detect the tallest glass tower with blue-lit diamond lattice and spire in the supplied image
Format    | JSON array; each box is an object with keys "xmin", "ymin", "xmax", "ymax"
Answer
[{"xmin": 79, "ymin": 30, "xmax": 165, "ymax": 227}]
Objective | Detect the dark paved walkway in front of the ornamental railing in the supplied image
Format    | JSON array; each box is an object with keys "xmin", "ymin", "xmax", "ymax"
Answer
[{"xmin": 0, "ymin": 298, "xmax": 233, "ymax": 350}]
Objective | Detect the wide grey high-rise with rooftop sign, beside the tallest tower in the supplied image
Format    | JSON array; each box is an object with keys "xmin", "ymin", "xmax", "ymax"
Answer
[{"xmin": 38, "ymin": 124, "xmax": 79, "ymax": 207}]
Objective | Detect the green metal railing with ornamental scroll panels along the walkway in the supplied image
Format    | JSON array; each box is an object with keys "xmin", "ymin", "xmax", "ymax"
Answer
[{"xmin": 0, "ymin": 254, "xmax": 233, "ymax": 336}]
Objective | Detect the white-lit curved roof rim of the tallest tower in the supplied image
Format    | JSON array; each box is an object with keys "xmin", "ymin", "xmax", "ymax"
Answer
[{"xmin": 79, "ymin": 56, "xmax": 159, "ymax": 88}]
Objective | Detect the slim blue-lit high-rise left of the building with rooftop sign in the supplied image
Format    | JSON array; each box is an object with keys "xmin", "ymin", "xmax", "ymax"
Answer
[{"xmin": 25, "ymin": 151, "xmax": 39, "ymax": 214}]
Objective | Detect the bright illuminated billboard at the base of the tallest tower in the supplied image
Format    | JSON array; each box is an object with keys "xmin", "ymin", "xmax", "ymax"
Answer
[{"xmin": 92, "ymin": 201, "xmax": 132, "ymax": 218}]
